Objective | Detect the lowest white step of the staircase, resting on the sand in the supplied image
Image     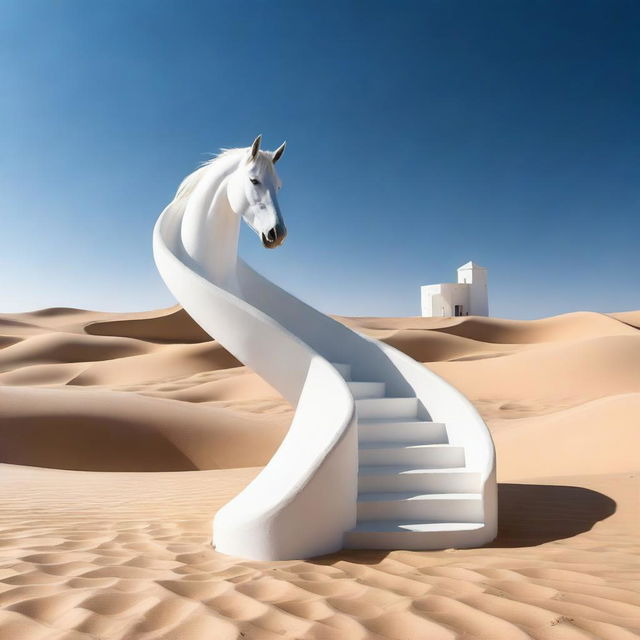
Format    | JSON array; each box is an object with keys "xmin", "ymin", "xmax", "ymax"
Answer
[{"xmin": 344, "ymin": 520, "xmax": 486, "ymax": 550}]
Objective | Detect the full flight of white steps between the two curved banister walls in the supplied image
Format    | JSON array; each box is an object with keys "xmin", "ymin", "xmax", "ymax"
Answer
[{"xmin": 334, "ymin": 370, "xmax": 485, "ymax": 549}]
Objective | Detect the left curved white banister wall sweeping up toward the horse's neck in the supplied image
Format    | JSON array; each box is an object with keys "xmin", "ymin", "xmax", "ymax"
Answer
[{"xmin": 154, "ymin": 198, "xmax": 357, "ymax": 559}]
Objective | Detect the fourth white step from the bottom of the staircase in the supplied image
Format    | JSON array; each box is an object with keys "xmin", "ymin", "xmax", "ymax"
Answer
[{"xmin": 358, "ymin": 442, "xmax": 464, "ymax": 468}]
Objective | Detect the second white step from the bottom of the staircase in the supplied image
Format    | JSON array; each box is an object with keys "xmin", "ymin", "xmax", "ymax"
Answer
[{"xmin": 358, "ymin": 492, "xmax": 484, "ymax": 522}]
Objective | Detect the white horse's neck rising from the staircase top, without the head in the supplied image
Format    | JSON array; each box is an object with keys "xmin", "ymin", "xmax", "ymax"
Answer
[{"xmin": 181, "ymin": 158, "xmax": 240, "ymax": 288}]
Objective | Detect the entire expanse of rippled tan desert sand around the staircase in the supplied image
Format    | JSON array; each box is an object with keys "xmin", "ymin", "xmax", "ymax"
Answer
[{"xmin": 0, "ymin": 307, "xmax": 640, "ymax": 640}]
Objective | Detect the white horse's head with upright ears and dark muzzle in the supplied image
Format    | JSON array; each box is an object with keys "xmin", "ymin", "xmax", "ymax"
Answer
[{"xmin": 227, "ymin": 136, "xmax": 287, "ymax": 249}]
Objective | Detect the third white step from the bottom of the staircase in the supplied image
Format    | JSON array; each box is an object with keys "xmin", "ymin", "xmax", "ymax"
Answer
[{"xmin": 358, "ymin": 465, "xmax": 480, "ymax": 493}]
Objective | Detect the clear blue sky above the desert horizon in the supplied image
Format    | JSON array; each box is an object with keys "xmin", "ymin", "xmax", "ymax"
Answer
[{"xmin": 0, "ymin": 0, "xmax": 640, "ymax": 318}]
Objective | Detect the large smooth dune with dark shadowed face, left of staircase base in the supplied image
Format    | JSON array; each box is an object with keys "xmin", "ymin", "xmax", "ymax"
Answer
[{"xmin": 0, "ymin": 387, "xmax": 288, "ymax": 471}]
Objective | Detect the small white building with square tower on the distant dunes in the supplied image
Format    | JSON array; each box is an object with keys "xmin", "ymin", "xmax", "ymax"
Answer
[{"xmin": 420, "ymin": 262, "xmax": 489, "ymax": 318}]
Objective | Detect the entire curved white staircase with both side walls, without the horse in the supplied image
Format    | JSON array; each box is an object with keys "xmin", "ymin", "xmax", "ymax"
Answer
[{"xmin": 154, "ymin": 146, "xmax": 497, "ymax": 560}]
